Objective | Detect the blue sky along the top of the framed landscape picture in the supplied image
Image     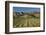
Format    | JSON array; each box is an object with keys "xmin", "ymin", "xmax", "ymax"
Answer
[{"xmin": 13, "ymin": 7, "xmax": 40, "ymax": 12}]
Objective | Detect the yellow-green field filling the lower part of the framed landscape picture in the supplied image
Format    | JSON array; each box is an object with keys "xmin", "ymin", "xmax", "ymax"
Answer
[{"xmin": 13, "ymin": 15, "xmax": 40, "ymax": 28}]
